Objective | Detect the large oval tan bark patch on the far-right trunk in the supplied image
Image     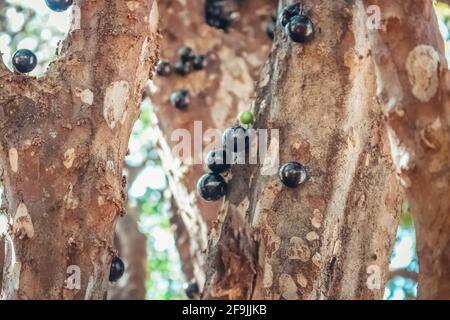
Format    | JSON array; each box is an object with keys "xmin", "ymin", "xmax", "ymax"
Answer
[{"xmin": 406, "ymin": 45, "xmax": 439, "ymax": 102}]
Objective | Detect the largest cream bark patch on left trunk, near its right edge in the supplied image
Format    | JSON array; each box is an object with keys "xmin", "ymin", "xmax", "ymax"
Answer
[{"xmin": 103, "ymin": 80, "xmax": 130, "ymax": 130}]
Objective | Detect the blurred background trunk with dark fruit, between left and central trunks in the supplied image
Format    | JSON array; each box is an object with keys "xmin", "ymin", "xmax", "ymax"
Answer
[{"xmin": 150, "ymin": 0, "xmax": 275, "ymax": 286}]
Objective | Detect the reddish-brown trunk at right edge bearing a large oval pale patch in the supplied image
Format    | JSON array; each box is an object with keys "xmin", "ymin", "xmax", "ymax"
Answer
[{"xmin": 364, "ymin": 0, "xmax": 450, "ymax": 299}]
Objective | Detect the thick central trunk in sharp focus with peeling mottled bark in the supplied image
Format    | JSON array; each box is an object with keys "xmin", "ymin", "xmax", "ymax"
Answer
[{"xmin": 203, "ymin": 0, "xmax": 400, "ymax": 299}]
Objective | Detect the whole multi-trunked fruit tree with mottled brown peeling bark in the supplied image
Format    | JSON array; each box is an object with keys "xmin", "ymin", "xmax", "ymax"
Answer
[{"xmin": 0, "ymin": 0, "xmax": 450, "ymax": 299}]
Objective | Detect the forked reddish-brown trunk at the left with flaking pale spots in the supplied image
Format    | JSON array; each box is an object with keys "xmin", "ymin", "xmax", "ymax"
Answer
[{"xmin": 0, "ymin": 0, "xmax": 158, "ymax": 299}]
